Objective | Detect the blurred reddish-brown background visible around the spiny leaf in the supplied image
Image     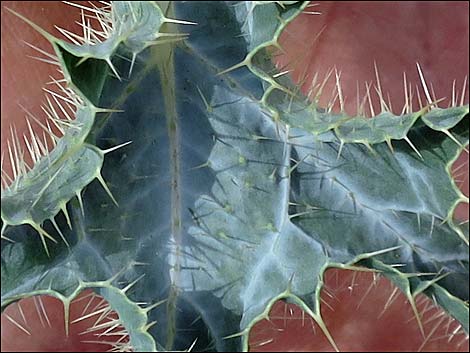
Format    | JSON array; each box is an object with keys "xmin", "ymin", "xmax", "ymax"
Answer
[{"xmin": 1, "ymin": 1, "xmax": 469, "ymax": 351}]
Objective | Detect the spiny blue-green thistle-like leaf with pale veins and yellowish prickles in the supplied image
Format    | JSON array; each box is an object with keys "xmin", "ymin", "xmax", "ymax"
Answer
[{"xmin": 1, "ymin": 1, "xmax": 469, "ymax": 351}]
